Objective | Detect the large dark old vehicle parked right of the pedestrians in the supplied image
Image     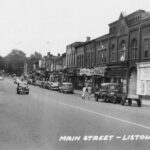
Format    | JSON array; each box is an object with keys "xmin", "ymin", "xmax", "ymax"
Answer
[{"xmin": 94, "ymin": 83, "xmax": 122, "ymax": 103}]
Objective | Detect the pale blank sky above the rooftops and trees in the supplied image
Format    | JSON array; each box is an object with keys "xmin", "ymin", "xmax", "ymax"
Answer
[{"xmin": 0, "ymin": 0, "xmax": 150, "ymax": 56}]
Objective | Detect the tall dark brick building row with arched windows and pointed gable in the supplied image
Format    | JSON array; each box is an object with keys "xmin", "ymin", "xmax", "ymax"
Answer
[{"xmin": 66, "ymin": 10, "xmax": 150, "ymax": 98}]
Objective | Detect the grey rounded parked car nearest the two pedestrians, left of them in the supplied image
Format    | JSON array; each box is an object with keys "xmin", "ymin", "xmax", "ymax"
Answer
[{"xmin": 59, "ymin": 82, "xmax": 74, "ymax": 94}]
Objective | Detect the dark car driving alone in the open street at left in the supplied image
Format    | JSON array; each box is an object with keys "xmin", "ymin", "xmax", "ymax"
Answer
[{"xmin": 17, "ymin": 82, "xmax": 29, "ymax": 94}]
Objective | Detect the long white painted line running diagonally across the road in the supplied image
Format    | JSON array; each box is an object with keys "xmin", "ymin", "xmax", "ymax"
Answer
[{"xmin": 60, "ymin": 103, "xmax": 150, "ymax": 130}]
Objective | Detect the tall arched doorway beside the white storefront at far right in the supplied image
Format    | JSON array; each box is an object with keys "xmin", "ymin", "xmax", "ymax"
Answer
[{"xmin": 128, "ymin": 68, "xmax": 137, "ymax": 98}]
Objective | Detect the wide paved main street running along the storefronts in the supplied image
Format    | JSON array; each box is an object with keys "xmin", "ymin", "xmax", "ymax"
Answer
[{"xmin": 0, "ymin": 78, "xmax": 150, "ymax": 150}]
